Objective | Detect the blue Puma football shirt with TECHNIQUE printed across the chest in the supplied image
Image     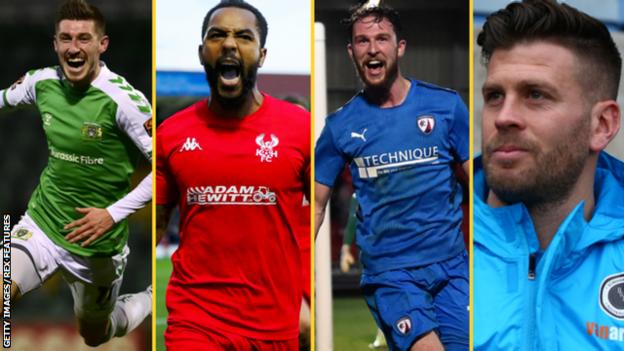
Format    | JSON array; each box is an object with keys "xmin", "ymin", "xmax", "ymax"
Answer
[{"xmin": 315, "ymin": 80, "xmax": 469, "ymax": 273}]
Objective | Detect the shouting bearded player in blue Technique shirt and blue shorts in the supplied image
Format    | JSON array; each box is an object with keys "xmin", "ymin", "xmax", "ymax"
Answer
[{"xmin": 315, "ymin": 3, "xmax": 469, "ymax": 351}]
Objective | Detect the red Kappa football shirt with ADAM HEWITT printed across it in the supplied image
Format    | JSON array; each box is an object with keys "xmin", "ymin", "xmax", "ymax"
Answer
[{"xmin": 156, "ymin": 95, "xmax": 310, "ymax": 340}]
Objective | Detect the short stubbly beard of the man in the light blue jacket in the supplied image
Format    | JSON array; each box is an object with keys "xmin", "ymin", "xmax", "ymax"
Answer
[{"xmin": 483, "ymin": 118, "xmax": 590, "ymax": 207}]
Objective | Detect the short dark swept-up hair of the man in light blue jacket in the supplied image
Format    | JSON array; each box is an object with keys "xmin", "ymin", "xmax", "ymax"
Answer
[{"xmin": 477, "ymin": 0, "xmax": 622, "ymax": 99}]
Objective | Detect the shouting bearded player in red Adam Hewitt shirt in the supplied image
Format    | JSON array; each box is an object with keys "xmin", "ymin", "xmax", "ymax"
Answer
[{"xmin": 156, "ymin": 0, "xmax": 310, "ymax": 351}]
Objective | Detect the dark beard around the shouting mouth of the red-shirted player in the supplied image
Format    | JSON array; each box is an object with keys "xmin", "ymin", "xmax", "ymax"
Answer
[{"xmin": 203, "ymin": 55, "xmax": 259, "ymax": 108}]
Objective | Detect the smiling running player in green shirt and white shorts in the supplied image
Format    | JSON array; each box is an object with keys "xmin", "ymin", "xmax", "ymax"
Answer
[{"xmin": 0, "ymin": 0, "xmax": 152, "ymax": 346}]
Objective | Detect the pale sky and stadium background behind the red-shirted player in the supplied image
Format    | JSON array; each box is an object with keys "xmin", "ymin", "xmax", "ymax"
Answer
[{"xmin": 155, "ymin": 0, "xmax": 311, "ymax": 351}]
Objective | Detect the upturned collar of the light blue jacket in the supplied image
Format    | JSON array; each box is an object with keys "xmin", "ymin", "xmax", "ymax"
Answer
[{"xmin": 474, "ymin": 152, "xmax": 624, "ymax": 263}]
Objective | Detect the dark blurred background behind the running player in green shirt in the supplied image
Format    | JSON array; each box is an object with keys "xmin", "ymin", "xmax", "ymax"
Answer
[{"xmin": 0, "ymin": 0, "xmax": 152, "ymax": 351}]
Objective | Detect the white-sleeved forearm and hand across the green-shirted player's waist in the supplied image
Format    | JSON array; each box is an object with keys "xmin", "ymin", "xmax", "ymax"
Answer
[{"xmin": 63, "ymin": 173, "xmax": 152, "ymax": 247}]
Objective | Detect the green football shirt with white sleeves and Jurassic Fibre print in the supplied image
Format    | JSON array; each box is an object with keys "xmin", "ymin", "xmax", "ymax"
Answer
[{"xmin": 0, "ymin": 64, "xmax": 152, "ymax": 256}]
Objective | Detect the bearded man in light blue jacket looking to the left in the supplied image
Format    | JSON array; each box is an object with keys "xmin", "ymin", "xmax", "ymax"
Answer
[{"xmin": 474, "ymin": 0, "xmax": 624, "ymax": 351}]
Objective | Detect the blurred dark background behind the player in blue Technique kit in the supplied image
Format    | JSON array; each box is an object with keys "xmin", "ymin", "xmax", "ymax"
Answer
[{"xmin": 315, "ymin": 0, "xmax": 469, "ymax": 351}]
